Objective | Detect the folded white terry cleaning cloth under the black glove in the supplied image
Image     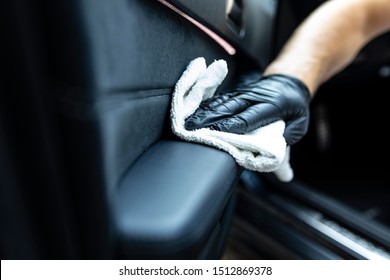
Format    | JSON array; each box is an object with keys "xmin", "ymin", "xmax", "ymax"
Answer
[{"xmin": 171, "ymin": 57, "xmax": 294, "ymax": 182}]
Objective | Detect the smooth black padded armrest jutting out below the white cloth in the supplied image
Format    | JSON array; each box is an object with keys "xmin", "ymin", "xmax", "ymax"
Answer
[{"xmin": 112, "ymin": 140, "xmax": 241, "ymax": 258}]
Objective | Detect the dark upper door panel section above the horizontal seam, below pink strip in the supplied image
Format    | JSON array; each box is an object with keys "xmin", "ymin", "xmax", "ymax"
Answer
[{"xmin": 45, "ymin": 0, "xmax": 238, "ymax": 97}]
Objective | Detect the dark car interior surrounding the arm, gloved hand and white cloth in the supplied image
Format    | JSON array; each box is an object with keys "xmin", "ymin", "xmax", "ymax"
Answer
[{"xmin": 0, "ymin": 0, "xmax": 390, "ymax": 260}]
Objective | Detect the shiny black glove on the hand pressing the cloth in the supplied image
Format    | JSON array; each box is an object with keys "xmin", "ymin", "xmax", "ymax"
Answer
[{"xmin": 185, "ymin": 74, "xmax": 310, "ymax": 145}]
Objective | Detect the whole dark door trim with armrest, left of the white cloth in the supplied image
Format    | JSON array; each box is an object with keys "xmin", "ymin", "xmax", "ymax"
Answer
[{"xmin": 0, "ymin": 0, "xmax": 247, "ymax": 259}]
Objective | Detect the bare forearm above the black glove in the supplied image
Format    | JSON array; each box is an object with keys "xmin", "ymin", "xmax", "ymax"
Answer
[{"xmin": 264, "ymin": 0, "xmax": 390, "ymax": 96}]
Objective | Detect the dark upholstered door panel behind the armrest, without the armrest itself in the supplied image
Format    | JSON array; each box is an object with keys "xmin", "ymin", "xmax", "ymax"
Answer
[{"xmin": 44, "ymin": 0, "xmax": 241, "ymax": 258}]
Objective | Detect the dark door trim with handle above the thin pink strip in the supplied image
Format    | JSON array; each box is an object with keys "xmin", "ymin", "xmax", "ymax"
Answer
[{"xmin": 160, "ymin": 0, "xmax": 278, "ymax": 68}]
